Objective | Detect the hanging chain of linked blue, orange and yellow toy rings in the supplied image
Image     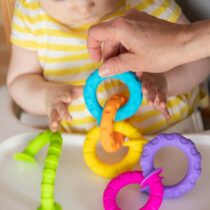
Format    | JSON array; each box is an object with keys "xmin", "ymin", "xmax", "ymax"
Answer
[{"xmin": 83, "ymin": 70, "xmax": 147, "ymax": 178}]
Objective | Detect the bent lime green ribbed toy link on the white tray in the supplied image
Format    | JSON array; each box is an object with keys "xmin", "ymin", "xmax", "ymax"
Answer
[{"xmin": 13, "ymin": 130, "xmax": 63, "ymax": 210}]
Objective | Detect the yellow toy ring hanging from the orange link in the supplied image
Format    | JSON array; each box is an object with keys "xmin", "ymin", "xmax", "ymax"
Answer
[{"xmin": 83, "ymin": 122, "xmax": 147, "ymax": 178}]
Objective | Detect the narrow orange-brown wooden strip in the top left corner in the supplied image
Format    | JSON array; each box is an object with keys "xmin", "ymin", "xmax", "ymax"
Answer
[{"xmin": 0, "ymin": 0, "xmax": 15, "ymax": 51}]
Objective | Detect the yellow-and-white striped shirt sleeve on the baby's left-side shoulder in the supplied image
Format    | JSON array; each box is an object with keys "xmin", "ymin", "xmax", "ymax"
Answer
[{"xmin": 10, "ymin": 0, "xmax": 38, "ymax": 50}]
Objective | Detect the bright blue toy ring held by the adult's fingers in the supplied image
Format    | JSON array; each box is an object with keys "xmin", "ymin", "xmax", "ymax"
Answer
[{"xmin": 84, "ymin": 69, "xmax": 143, "ymax": 125}]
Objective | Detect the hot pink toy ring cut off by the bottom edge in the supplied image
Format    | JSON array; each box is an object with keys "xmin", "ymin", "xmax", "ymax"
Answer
[{"xmin": 103, "ymin": 169, "xmax": 163, "ymax": 210}]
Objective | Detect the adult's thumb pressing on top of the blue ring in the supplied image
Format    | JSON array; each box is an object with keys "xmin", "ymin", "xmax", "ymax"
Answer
[{"xmin": 99, "ymin": 53, "xmax": 132, "ymax": 77}]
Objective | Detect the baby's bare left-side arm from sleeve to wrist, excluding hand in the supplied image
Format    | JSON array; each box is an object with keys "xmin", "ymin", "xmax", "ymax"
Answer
[{"xmin": 7, "ymin": 45, "xmax": 48, "ymax": 115}]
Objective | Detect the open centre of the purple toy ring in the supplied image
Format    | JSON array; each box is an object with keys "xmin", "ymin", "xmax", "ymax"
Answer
[{"xmin": 154, "ymin": 146, "xmax": 188, "ymax": 186}]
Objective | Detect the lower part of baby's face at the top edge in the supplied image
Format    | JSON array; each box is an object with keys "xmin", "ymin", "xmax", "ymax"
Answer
[{"xmin": 39, "ymin": 0, "xmax": 122, "ymax": 26}]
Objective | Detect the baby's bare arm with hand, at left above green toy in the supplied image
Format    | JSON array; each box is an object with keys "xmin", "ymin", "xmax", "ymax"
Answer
[{"xmin": 7, "ymin": 45, "xmax": 82, "ymax": 130}]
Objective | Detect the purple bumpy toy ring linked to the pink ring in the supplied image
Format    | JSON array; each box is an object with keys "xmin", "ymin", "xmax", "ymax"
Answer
[{"xmin": 140, "ymin": 133, "xmax": 201, "ymax": 198}]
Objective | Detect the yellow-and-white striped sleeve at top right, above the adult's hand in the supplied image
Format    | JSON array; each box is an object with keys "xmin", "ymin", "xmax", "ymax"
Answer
[{"xmin": 127, "ymin": 0, "xmax": 182, "ymax": 22}]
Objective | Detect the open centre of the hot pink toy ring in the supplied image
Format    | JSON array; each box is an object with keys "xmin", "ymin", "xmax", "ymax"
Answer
[{"xmin": 116, "ymin": 184, "xmax": 148, "ymax": 210}]
